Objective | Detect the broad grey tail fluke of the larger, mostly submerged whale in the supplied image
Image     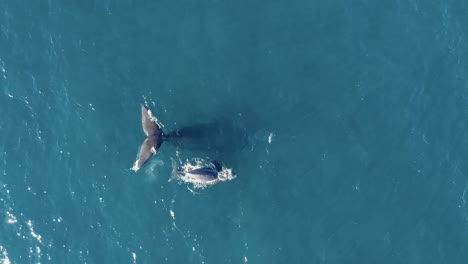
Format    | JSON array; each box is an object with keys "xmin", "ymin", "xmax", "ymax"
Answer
[{"xmin": 132, "ymin": 104, "xmax": 163, "ymax": 171}]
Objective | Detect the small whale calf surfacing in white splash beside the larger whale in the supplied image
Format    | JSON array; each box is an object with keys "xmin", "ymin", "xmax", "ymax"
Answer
[{"xmin": 170, "ymin": 160, "xmax": 223, "ymax": 183}]
